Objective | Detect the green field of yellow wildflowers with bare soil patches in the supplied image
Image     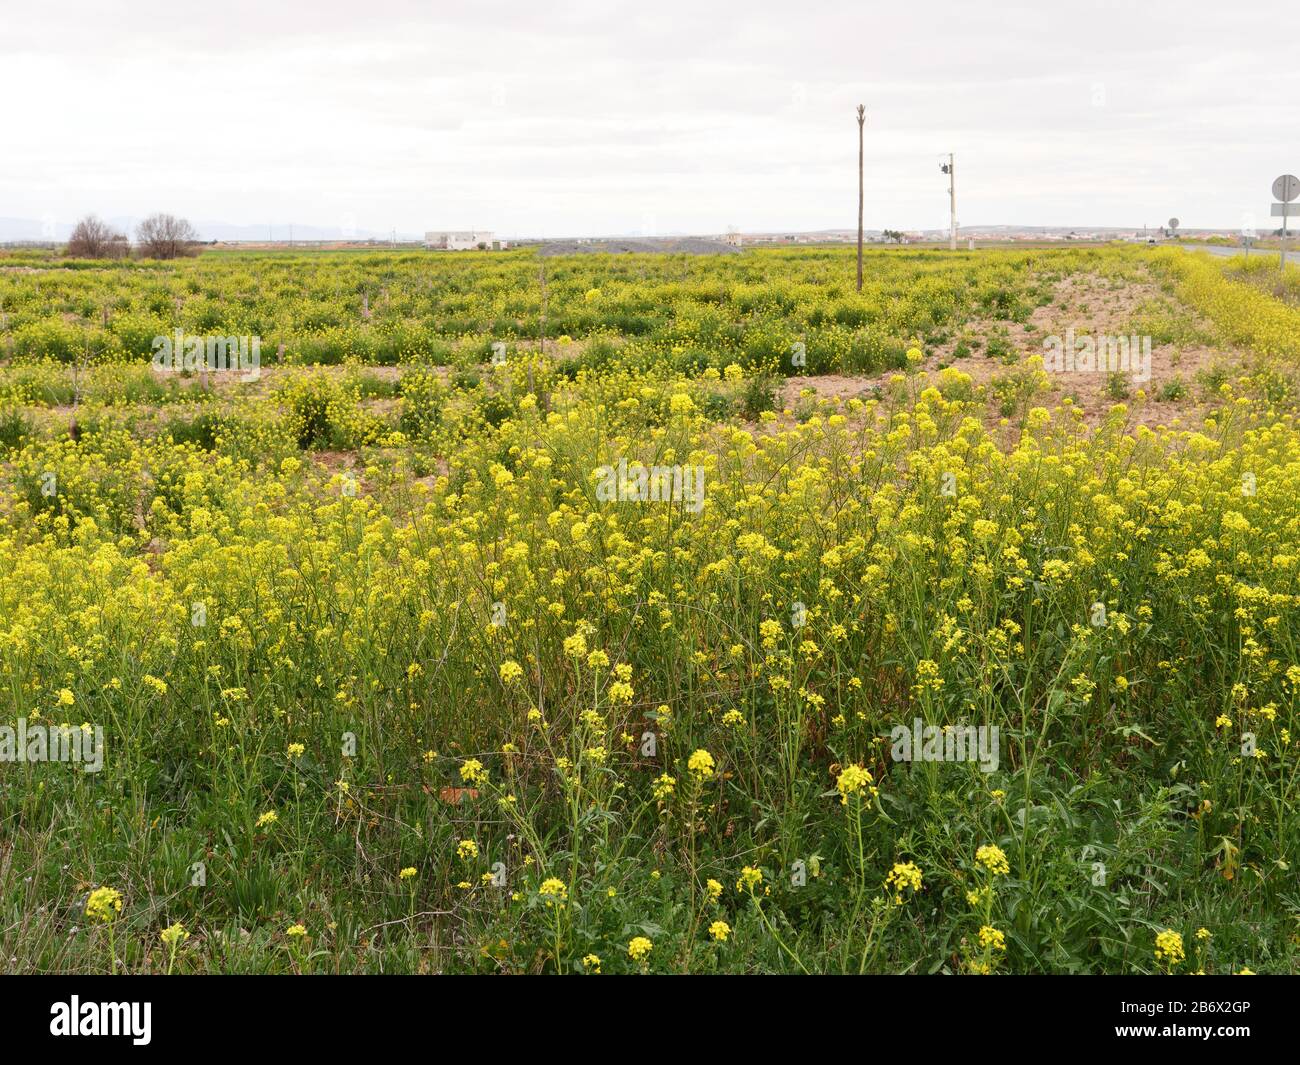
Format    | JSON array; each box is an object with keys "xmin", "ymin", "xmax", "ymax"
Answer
[{"xmin": 0, "ymin": 247, "xmax": 1300, "ymax": 975}]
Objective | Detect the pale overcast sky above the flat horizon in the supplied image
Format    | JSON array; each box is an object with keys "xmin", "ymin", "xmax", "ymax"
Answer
[{"xmin": 0, "ymin": 0, "xmax": 1300, "ymax": 237}]
